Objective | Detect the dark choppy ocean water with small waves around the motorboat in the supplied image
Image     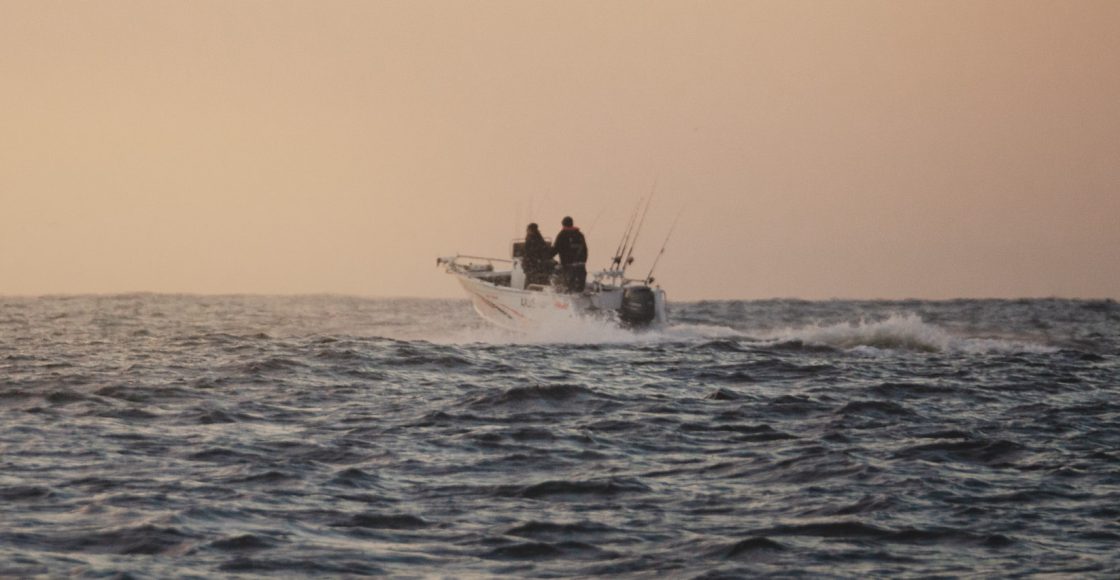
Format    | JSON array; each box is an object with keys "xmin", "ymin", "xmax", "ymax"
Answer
[{"xmin": 0, "ymin": 294, "xmax": 1120, "ymax": 578}]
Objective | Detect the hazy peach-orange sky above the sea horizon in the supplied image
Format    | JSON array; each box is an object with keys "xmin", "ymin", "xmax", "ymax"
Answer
[{"xmin": 0, "ymin": 0, "xmax": 1120, "ymax": 299}]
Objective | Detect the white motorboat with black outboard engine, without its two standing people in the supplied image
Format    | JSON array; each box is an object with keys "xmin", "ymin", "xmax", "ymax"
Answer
[{"xmin": 436, "ymin": 220, "xmax": 669, "ymax": 331}]
